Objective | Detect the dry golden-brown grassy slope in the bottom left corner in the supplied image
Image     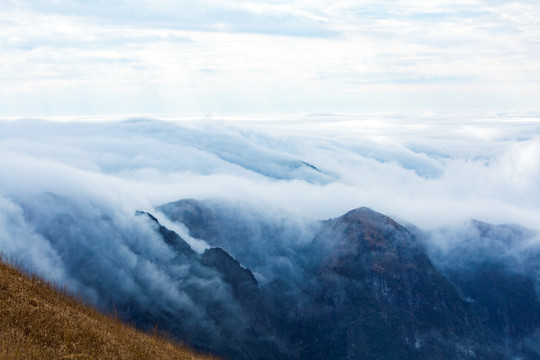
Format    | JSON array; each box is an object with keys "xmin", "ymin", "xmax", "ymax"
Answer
[{"xmin": 0, "ymin": 259, "xmax": 219, "ymax": 360}]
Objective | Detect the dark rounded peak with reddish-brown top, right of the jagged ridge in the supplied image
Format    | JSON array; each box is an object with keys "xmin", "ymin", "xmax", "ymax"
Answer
[{"xmin": 265, "ymin": 208, "xmax": 496, "ymax": 359}]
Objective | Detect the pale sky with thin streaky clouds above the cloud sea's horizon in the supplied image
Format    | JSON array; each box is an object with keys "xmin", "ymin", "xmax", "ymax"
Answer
[{"xmin": 0, "ymin": 0, "xmax": 540, "ymax": 117}]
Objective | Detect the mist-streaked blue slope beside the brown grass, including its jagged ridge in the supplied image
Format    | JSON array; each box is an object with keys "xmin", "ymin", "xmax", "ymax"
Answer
[{"xmin": 9, "ymin": 193, "xmax": 287, "ymax": 359}]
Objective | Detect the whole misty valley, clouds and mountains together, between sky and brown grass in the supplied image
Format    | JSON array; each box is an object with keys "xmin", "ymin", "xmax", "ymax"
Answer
[{"xmin": 0, "ymin": 113, "xmax": 540, "ymax": 359}]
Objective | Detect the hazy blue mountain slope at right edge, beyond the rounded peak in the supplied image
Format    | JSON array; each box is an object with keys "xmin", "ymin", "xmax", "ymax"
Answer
[{"xmin": 420, "ymin": 220, "xmax": 540, "ymax": 359}]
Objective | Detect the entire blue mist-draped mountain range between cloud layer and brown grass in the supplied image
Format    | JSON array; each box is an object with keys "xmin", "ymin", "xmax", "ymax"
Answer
[{"xmin": 7, "ymin": 194, "xmax": 540, "ymax": 360}]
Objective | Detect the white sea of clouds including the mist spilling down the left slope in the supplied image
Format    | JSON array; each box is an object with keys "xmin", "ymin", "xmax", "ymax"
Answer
[{"xmin": 0, "ymin": 113, "xmax": 540, "ymax": 318}]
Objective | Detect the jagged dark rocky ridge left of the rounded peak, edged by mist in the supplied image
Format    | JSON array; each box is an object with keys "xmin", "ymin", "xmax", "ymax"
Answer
[{"xmin": 131, "ymin": 211, "xmax": 287, "ymax": 359}]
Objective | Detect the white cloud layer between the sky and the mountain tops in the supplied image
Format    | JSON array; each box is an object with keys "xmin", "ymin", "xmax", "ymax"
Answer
[{"xmin": 0, "ymin": 113, "xmax": 540, "ymax": 228}]
